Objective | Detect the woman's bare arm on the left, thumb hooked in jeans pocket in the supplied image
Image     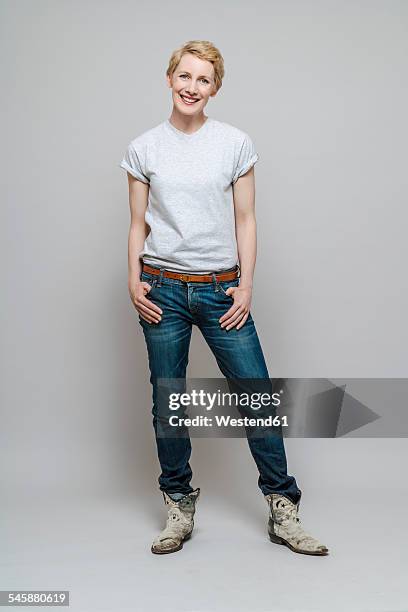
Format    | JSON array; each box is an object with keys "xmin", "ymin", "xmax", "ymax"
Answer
[{"xmin": 127, "ymin": 172, "xmax": 162, "ymax": 322}]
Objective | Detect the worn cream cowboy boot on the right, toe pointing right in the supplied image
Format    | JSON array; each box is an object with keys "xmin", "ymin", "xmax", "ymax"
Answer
[{"xmin": 264, "ymin": 493, "xmax": 329, "ymax": 555}]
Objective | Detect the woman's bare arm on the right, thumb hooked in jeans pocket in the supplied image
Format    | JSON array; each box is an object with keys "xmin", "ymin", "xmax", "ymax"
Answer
[{"xmin": 220, "ymin": 166, "xmax": 256, "ymax": 329}]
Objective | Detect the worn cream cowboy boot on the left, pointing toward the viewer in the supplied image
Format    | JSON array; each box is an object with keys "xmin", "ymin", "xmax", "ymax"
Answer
[{"xmin": 151, "ymin": 489, "xmax": 200, "ymax": 555}]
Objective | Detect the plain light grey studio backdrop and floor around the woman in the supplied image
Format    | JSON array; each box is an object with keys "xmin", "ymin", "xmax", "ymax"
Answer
[{"xmin": 0, "ymin": 0, "xmax": 408, "ymax": 612}]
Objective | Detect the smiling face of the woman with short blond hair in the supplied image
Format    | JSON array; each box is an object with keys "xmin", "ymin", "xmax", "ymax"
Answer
[{"xmin": 166, "ymin": 53, "xmax": 216, "ymax": 116}]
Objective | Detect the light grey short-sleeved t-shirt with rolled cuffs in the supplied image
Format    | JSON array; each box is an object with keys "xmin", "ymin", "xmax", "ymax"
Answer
[{"xmin": 119, "ymin": 117, "xmax": 259, "ymax": 274}]
